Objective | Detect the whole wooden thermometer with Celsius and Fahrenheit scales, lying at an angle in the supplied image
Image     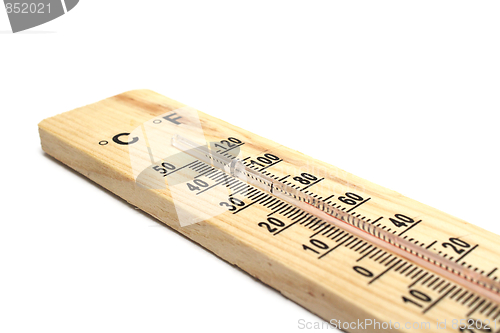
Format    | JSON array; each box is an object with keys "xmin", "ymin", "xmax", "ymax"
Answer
[{"xmin": 39, "ymin": 90, "xmax": 500, "ymax": 333}]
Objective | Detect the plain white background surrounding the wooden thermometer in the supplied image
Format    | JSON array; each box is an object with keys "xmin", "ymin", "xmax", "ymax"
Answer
[{"xmin": 0, "ymin": 0, "xmax": 500, "ymax": 333}]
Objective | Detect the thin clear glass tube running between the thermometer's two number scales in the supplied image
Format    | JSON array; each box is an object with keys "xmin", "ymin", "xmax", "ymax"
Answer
[{"xmin": 172, "ymin": 135, "xmax": 500, "ymax": 304}]
